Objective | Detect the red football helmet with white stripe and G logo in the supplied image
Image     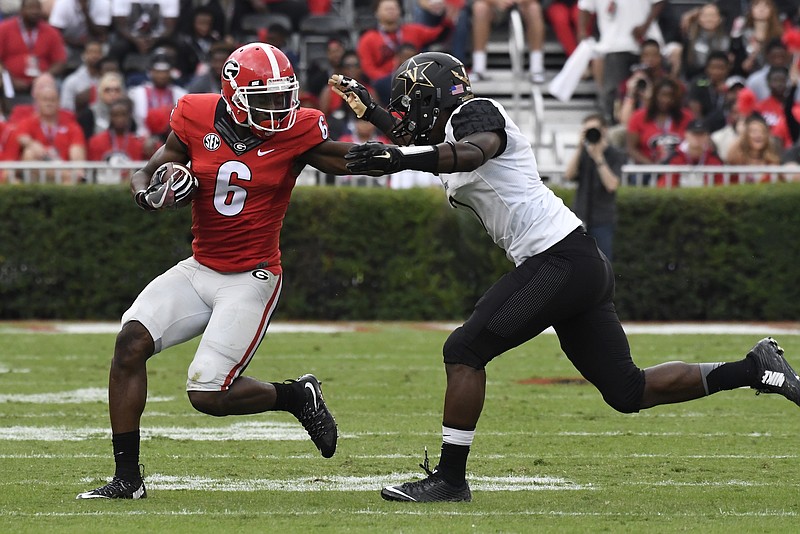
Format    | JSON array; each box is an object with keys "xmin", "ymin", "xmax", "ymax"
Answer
[{"xmin": 221, "ymin": 43, "xmax": 300, "ymax": 138}]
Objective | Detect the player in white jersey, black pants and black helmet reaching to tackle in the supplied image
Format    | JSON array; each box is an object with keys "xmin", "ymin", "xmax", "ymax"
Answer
[{"xmin": 329, "ymin": 52, "xmax": 800, "ymax": 502}]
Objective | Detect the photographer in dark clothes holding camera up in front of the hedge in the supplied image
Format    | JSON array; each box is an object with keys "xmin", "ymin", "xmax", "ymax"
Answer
[{"xmin": 564, "ymin": 113, "xmax": 626, "ymax": 261}]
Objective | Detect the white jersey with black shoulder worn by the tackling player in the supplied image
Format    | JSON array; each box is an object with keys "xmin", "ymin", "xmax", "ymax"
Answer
[{"xmin": 440, "ymin": 98, "xmax": 581, "ymax": 265}]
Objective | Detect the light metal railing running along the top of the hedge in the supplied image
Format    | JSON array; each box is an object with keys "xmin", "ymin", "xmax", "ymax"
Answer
[{"xmin": 0, "ymin": 161, "xmax": 800, "ymax": 187}]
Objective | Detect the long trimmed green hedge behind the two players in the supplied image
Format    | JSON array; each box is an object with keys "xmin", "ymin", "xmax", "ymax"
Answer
[{"xmin": 0, "ymin": 184, "xmax": 800, "ymax": 320}]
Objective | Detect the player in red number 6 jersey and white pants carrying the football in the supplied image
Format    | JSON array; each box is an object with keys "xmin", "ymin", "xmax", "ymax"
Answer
[{"xmin": 78, "ymin": 43, "xmax": 360, "ymax": 499}]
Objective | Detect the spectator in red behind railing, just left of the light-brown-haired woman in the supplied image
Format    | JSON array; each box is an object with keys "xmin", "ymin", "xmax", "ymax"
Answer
[{"xmin": 658, "ymin": 119, "xmax": 725, "ymax": 187}]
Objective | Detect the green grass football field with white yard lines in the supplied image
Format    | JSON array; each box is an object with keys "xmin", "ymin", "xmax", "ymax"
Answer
[{"xmin": 0, "ymin": 323, "xmax": 800, "ymax": 533}]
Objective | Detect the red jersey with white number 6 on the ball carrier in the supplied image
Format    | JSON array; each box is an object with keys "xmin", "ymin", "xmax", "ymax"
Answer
[{"xmin": 170, "ymin": 94, "xmax": 328, "ymax": 274}]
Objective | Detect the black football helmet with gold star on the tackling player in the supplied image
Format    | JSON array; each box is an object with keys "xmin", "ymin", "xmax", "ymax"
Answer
[{"xmin": 388, "ymin": 52, "xmax": 474, "ymax": 145}]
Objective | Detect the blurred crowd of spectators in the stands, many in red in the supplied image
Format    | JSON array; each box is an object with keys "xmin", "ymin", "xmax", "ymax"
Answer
[{"xmin": 0, "ymin": 0, "xmax": 800, "ymax": 185}]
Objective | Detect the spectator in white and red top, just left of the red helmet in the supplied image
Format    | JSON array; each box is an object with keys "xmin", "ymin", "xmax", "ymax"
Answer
[{"xmin": 128, "ymin": 55, "xmax": 186, "ymax": 137}]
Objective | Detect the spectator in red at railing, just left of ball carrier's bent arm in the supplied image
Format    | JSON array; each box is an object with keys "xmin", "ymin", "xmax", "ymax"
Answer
[{"xmin": 88, "ymin": 97, "xmax": 153, "ymax": 183}]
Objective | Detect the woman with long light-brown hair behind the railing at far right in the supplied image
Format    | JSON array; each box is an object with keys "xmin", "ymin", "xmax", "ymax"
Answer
[{"xmin": 725, "ymin": 113, "xmax": 781, "ymax": 183}]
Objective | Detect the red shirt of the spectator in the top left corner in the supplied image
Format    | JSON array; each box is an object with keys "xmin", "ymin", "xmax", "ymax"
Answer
[{"xmin": 0, "ymin": 16, "xmax": 67, "ymax": 85}]
